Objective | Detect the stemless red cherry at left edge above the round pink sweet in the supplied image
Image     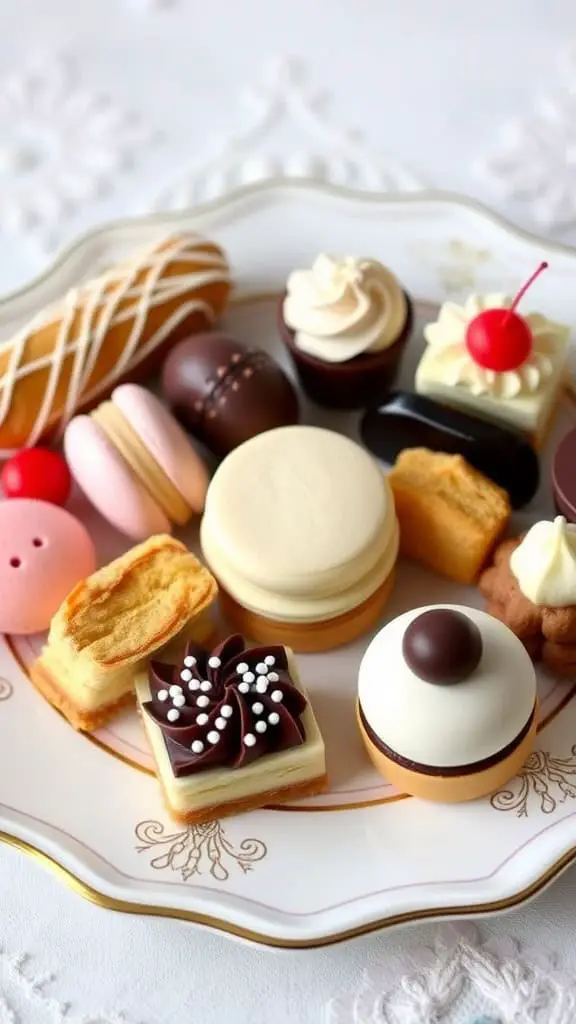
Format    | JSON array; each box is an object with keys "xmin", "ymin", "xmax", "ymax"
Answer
[{"xmin": 0, "ymin": 449, "xmax": 72, "ymax": 505}]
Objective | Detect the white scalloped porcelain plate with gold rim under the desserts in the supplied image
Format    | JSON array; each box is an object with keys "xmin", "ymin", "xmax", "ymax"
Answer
[{"xmin": 0, "ymin": 182, "xmax": 576, "ymax": 946}]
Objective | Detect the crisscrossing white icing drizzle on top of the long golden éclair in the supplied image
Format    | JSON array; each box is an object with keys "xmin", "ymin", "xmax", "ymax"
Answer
[{"xmin": 0, "ymin": 233, "xmax": 231, "ymax": 446}]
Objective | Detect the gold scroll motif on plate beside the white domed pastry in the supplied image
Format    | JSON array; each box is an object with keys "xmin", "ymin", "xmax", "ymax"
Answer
[{"xmin": 490, "ymin": 743, "xmax": 576, "ymax": 818}]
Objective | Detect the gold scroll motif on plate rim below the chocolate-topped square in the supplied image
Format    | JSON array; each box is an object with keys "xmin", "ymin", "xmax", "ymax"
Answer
[{"xmin": 134, "ymin": 820, "xmax": 268, "ymax": 882}]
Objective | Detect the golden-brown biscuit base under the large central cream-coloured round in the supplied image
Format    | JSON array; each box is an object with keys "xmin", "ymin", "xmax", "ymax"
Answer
[{"xmin": 219, "ymin": 569, "xmax": 396, "ymax": 654}]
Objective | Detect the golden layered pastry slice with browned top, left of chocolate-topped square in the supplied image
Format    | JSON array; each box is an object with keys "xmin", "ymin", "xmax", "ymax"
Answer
[{"xmin": 31, "ymin": 535, "xmax": 217, "ymax": 731}]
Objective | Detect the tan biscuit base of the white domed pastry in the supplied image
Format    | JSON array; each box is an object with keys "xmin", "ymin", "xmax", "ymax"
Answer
[{"xmin": 356, "ymin": 701, "xmax": 538, "ymax": 804}]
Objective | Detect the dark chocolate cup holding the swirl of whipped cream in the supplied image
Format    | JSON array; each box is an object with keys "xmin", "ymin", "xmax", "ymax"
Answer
[{"xmin": 278, "ymin": 295, "xmax": 413, "ymax": 409}]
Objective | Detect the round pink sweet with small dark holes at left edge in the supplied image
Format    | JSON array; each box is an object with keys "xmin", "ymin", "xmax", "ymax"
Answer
[{"xmin": 0, "ymin": 498, "xmax": 96, "ymax": 634}]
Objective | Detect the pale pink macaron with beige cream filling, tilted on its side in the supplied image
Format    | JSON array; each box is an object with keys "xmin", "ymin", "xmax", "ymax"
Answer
[{"xmin": 64, "ymin": 384, "xmax": 208, "ymax": 541}]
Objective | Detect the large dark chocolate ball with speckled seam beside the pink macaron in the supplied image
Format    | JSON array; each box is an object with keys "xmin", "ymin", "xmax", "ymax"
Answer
[{"xmin": 162, "ymin": 332, "xmax": 299, "ymax": 456}]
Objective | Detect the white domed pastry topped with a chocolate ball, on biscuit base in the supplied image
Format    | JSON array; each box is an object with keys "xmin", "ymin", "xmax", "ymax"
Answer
[{"xmin": 357, "ymin": 604, "xmax": 537, "ymax": 803}]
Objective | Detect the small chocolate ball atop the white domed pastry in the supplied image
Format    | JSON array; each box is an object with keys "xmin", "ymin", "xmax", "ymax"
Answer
[{"xmin": 402, "ymin": 608, "xmax": 482, "ymax": 686}]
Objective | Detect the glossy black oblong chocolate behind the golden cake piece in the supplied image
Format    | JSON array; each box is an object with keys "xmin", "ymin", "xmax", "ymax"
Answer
[{"xmin": 360, "ymin": 391, "xmax": 540, "ymax": 509}]
